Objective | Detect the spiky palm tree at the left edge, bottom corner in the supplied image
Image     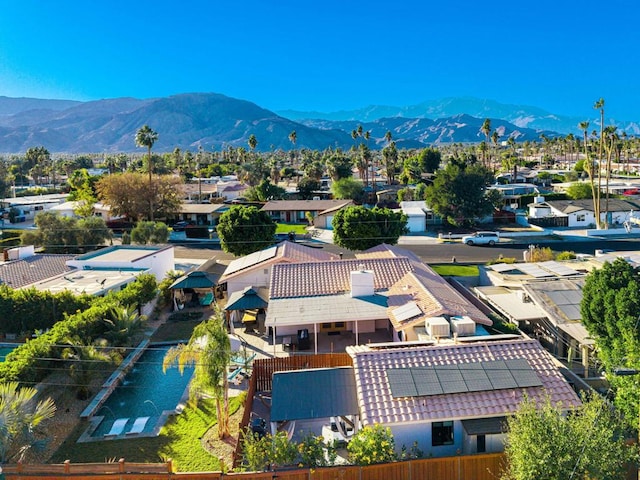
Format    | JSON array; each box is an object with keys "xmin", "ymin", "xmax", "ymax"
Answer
[{"xmin": 0, "ymin": 382, "xmax": 56, "ymax": 463}]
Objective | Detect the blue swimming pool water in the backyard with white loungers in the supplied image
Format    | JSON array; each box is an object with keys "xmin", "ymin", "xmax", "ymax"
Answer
[{"xmin": 91, "ymin": 345, "xmax": 194, "ymax": 437}]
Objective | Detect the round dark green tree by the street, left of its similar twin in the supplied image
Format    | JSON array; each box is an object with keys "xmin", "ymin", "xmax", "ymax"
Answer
[{"xmin": 216, "ymin": 205, "xmax": 276, "ymax": 256}]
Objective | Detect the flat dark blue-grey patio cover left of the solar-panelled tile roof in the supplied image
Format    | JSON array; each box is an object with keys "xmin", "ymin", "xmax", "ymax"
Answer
[{"xmin": 271, "ymin": 367, "xmax": 359, "ymax": 422}]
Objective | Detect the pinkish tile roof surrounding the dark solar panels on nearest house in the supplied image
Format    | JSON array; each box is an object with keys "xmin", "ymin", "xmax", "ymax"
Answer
[{"xmin": 347, "ymin": 340, "xmax": 580, "ymax": 425}]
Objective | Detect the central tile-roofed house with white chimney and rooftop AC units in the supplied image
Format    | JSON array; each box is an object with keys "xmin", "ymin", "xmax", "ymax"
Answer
[{"xmin": 265, "ymin": 244, "xmax": 492, "ymax": 351}]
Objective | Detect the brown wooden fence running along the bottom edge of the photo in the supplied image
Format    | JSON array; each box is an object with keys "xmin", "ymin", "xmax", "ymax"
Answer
[{"xmin": 3, "ymin": 453, "xmax": 504, "ymax": 480}]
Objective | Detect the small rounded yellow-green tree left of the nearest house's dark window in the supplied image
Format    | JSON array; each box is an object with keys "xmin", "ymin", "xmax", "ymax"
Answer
[{"xmin": 347, "ymin": 424, "xmax": 397, "ymax": 465}]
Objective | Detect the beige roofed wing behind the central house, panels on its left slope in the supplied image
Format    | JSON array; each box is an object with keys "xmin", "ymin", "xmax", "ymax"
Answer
[{"xmin": 218, "ymin": 241, "xmax": 340, "ymax": 296}]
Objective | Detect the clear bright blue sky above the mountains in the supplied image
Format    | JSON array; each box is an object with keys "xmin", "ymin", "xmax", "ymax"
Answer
[{"xmin": 0, "ymin": 0, "xmax": 640, "ymax": 121}]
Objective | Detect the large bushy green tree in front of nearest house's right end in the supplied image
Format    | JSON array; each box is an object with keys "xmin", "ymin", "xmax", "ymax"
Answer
[{"xmin": 502, "ymin": 395, "xmax": 636, "ymax": 480}]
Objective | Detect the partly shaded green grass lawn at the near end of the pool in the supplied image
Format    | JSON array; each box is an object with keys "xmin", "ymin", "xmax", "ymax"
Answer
[{"xmin": 50, "ymin": 394, "xmax": 245, "ymax": 472}]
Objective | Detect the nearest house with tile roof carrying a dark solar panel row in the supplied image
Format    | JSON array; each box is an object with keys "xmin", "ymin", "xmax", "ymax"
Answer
[{"xmin": 347, "ymin": 338, "xmax": 580, "ymax": 457}]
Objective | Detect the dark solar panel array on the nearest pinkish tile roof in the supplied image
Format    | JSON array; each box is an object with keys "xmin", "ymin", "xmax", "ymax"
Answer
[{"xmin": 387, "ymin": 359, "xmax": 542, "ymax": 398}]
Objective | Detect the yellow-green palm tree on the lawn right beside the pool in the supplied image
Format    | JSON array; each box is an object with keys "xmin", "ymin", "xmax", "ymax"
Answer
[{"xmin": 162, "ymin": 309, "xmax": 231, "ymax": 439}]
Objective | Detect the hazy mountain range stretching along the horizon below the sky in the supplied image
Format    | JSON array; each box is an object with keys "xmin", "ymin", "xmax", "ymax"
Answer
[{"xmin": 0, "ymin": 93, "xmax": 640, "ymax": 153}]
